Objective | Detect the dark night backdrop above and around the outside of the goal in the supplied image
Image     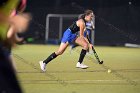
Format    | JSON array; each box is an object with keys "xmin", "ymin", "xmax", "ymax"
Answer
[{"xmin": 25, "ymin": 0, "xmax": 140, "ymax": 46}]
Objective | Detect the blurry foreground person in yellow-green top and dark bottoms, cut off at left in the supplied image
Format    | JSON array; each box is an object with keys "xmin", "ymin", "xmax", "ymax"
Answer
[{"xmin": 0, "ymin": 0, "xmax": 29, "ymax": 93}]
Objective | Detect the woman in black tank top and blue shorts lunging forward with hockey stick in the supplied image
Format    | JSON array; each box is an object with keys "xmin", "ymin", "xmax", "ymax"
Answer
[{"xmin": 39, "ymin": 10, "xmax": 94, "ymax": 71}]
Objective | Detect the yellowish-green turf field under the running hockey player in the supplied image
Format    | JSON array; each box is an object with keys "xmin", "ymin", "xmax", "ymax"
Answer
[{"xmin": 13, "ymin": 45, "xmax": 140, "ymax": 93}]
